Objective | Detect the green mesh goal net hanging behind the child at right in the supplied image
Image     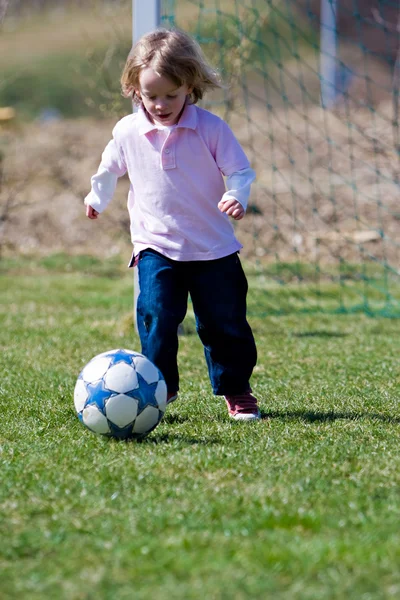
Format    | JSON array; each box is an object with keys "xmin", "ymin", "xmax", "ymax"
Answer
[{"xmin": 161, "ymin": 0, "xmax": 400, "ymax": 317}]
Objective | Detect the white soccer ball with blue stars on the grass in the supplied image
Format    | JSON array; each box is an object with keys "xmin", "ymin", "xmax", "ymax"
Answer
[{"xmin": 74, "ymin": 350, "xmax": 167, "ymax": 439}]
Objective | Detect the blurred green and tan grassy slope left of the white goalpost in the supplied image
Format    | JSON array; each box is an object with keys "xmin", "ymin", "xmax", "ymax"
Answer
[{"xmin": 0, "ymin": 3, "xmax": 132, "ymax": 120}]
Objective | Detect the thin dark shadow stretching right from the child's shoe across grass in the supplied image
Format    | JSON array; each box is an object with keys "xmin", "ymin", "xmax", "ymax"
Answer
[{"xmin": 261, "ymin": 410, "xmax": 400, "ymax": 424}]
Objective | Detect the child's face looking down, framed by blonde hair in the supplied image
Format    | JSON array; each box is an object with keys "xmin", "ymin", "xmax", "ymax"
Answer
[{"xmin": 135, "ymin": 67, "xmax": 193, "ymax": 125}]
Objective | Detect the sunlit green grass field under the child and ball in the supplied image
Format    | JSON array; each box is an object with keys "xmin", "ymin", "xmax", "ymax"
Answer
[{"xmin": 0, "ymin": 257, "xmax": 400, "ymax": 600}]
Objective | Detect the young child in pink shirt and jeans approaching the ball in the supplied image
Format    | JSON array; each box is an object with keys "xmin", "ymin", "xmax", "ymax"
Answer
[{"xmin": 85, "ymin": 29, "xmax": 260, "ymax": 421}]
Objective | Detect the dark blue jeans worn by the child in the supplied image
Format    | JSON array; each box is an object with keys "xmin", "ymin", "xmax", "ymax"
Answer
[{"xmin": 137, "ymin": 249, "xmax": 257, "ymax": 395}]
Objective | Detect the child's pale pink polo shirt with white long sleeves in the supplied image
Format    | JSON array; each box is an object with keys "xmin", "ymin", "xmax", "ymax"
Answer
[{"xmin": 85, "ymin": 104, "xmax": 255, "ymax": 261}]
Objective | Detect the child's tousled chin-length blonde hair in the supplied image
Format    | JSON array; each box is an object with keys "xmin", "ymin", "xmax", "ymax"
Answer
[{"xmin": 121, "ymin": 28, "xmax": 221, "ymax": 104}]
